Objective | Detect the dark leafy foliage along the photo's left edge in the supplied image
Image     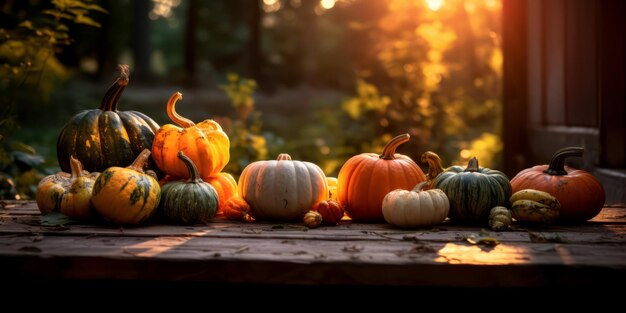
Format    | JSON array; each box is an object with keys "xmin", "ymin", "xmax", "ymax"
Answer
[{"xmin": 0, "ymin": 0, "xmax": 106, "ymax": 199}]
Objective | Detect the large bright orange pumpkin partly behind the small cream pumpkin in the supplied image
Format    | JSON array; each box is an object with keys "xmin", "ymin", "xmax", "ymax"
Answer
[{"xmin": 337, "ymin": 134, "xmax": 426, "ymax": 222}]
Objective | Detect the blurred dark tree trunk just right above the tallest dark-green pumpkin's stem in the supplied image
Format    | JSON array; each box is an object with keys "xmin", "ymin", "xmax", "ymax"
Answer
[{"xmin": 131, "ymin": 0, "xmax": 152, "ymax": 83}]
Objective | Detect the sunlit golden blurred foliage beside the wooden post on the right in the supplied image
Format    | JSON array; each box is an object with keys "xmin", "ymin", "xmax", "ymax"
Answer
[{"xmin": 332, "ymin": 0, "xmax": 502, "ymax": 168}]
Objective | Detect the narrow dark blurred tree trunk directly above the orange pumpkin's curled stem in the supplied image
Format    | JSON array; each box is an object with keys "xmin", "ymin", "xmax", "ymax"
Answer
[{"xmin": 184, "ymin": 0, "xmax": 199, "ymax": 87}]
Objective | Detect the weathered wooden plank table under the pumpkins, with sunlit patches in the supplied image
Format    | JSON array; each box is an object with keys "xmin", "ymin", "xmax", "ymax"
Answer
[{"xmin": 0, "ymin": 201, "xmax": 626, "ymax": 288}]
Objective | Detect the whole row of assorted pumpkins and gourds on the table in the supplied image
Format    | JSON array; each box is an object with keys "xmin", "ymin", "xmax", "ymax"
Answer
[{"xmin": 36, "ymin": 65, "xmax": 604, "ymax": 228}]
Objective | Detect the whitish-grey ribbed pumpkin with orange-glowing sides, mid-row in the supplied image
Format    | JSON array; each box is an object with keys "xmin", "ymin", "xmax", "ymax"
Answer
[{"xmin": 239, "ymin": 154, "xmax": 328, "ymax": 221}]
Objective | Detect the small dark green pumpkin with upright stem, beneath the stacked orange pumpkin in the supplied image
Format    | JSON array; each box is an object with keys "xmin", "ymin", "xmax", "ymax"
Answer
[{"xmin": 158, "ymin": 151, "xmax": 219, "ymax": 225}]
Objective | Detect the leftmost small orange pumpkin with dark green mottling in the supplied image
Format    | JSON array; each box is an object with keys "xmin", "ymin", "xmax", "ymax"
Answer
[{"xmin": 35, "ymin": 156, "xmax": 99, "ymax": 219}]
